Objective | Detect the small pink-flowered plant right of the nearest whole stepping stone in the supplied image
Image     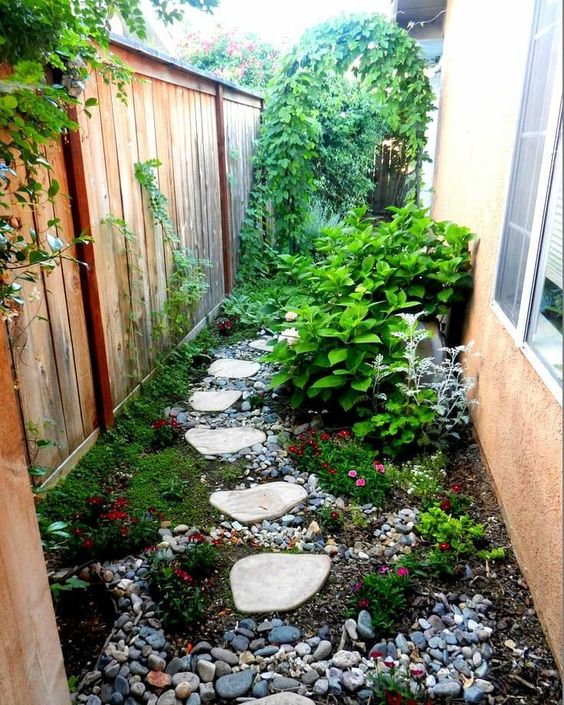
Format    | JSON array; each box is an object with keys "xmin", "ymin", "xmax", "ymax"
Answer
[{"xmin": 350, "ymin": 565, "xmax": 411, "ymax": 636}]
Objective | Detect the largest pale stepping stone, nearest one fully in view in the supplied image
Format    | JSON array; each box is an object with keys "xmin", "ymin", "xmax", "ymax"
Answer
[{"xmin": 230, "ymin": 553, "xmax": 331, "ymax": 614}]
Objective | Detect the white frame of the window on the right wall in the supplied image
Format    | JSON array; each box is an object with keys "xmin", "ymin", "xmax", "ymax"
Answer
[{"xmin": 491, "ymin": 2, "xmax": 563, "ymax": 405}]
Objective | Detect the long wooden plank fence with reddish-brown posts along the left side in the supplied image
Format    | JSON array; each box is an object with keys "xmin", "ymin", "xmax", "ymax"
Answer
[{"xmin": 2, "ymin": 37, "xmax": 262, "ymax": 484}]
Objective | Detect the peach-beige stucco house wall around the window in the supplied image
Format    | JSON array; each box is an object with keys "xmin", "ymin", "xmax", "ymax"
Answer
[{"xmin": 433, "ymin": 0, "xmax": 562, "ymax": 665}]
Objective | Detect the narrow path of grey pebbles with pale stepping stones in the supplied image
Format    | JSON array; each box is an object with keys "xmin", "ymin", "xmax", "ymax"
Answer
[{"xmin": 78, "ymin": 337, "xmax": 552, "ymax": 705}]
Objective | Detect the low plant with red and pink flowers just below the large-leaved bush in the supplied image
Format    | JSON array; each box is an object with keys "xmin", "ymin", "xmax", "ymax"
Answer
[{"xmin": 288, "ymin": 429, "xmax": 390, "ymax": 506}]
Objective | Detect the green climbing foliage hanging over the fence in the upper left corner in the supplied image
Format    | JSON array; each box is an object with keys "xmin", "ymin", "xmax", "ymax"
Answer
[{"xmin": 0, "ymin": 0, "xmax": 217, "ymax": 319}]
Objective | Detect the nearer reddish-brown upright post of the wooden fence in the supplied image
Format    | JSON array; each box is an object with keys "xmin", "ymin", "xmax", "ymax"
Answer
[{"xmin": 63, "ymin": 107, "xmax": 114, "ymax": 428}]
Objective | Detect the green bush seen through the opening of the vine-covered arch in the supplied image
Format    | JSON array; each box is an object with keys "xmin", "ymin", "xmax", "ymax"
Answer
[{"xmin": 312, "ymin": 75, "xmax": 387, "ymax": 214}]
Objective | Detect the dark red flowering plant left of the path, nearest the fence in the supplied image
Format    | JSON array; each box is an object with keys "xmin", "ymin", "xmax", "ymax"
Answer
[{"xmin": 68, "ymin": 488, "xmax": 160, "ymax": 560}]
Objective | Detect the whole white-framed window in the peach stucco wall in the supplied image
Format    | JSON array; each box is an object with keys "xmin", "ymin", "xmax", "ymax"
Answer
[{"xmin": 495, "ymin": 0, "xmax": 562, "ymax": 389}]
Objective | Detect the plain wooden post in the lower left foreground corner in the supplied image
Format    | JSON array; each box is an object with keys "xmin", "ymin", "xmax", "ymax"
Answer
[{"xmin": 0, "ymin": 324, "xmax": 70, "ymax": 705}]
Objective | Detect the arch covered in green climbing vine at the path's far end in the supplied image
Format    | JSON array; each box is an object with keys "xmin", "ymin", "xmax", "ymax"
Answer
[{"xmin": 243, "ymin": 14, "xmax": 433, "ymax": 264}]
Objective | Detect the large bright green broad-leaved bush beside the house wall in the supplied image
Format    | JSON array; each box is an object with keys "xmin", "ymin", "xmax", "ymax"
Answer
[{"xmin": 269, "ymin": 204, "xmax": 471, "ymax": 445}]
